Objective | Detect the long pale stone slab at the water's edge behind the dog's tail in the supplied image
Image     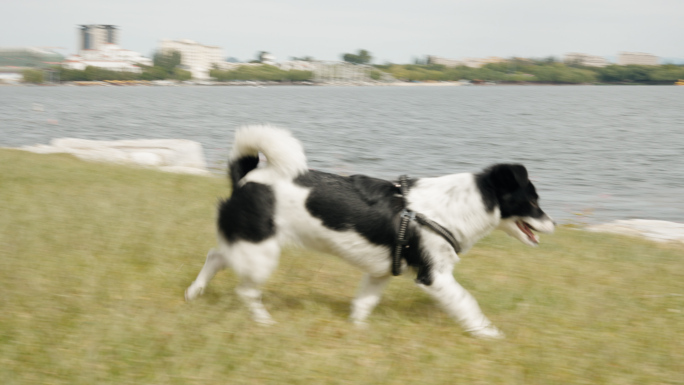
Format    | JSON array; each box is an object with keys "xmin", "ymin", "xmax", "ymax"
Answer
[{"xmin": 21, "ymin": 138, "xmax": 211, "ymax": 175}]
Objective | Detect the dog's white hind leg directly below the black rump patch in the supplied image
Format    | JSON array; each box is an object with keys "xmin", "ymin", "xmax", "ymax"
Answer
[{"xmin": 230, "ymin": 238, "xmax": 280, "ymax": 325}]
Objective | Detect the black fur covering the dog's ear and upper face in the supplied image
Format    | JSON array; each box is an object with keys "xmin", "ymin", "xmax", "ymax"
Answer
[{"xmin": 475, "ymin": 164, "xmax": 546, "ymax": 218}]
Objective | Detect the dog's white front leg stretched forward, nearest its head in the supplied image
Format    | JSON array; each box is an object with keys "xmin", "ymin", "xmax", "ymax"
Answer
[{"xmin": 418, "ymin": 271, "xmax": 504, "ymax": 338}]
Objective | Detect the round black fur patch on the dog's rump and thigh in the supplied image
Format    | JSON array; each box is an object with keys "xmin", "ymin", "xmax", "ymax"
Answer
[{"xmin": 218, "ymin": 182, "xmax": 275, "ymax": 243}]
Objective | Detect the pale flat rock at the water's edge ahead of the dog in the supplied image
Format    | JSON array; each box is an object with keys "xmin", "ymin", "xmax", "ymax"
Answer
[{"xmin": 586, "ymin": 219, "xmax": 684, "ymax": 243}]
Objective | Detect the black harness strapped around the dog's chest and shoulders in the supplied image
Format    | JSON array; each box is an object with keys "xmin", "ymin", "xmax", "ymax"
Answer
[{"xmin": 392, "ymin": 175, "xmax": 461, "ymax": 276}]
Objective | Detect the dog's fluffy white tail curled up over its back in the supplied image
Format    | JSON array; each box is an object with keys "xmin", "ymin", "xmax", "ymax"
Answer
[{"xmin": 228, "ymin": 126, "xmax": 307, "ymax": 186}]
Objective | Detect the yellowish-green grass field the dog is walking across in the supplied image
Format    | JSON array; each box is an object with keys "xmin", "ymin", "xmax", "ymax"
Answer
[{"xmin": 0, "ymin": 150, "xmax": 684, "ymax": 385}]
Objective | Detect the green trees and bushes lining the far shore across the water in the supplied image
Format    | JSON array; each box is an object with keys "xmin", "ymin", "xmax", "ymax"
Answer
[{"xmin": 24, "ymin": 50, "xmax": 684, "ymax": 84}]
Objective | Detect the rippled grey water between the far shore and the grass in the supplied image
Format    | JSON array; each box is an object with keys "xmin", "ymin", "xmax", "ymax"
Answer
[{"xmin": 0, "ymin": 86, "xmax": 684, "ymax": 222}]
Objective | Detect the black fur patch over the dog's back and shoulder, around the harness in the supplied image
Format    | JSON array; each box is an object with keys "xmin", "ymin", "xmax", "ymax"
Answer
[{"xmin": 295, "ymin": 171, "xmax": 432, "ymax": 285}]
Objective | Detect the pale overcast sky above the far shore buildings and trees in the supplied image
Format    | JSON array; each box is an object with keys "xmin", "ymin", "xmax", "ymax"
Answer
[{"xmin": 0, "ymin": 0, "xmax": 684, "ymax": 64}]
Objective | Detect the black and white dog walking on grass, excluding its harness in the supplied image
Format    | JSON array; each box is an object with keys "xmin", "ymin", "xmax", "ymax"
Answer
[{"xmin": 185, "ymin": 126, "xmax": 554, "ymax": 338}]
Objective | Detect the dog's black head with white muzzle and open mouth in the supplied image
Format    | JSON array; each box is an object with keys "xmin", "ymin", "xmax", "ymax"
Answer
[{"xmin": 478, "ymin": 164, "xmax": 555, "ymax": 246}]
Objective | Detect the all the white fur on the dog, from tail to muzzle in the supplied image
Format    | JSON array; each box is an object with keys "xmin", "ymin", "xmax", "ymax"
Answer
[{"xmin": 185, "ymin": 126, "xmax": 554, "ymax": 338}]
